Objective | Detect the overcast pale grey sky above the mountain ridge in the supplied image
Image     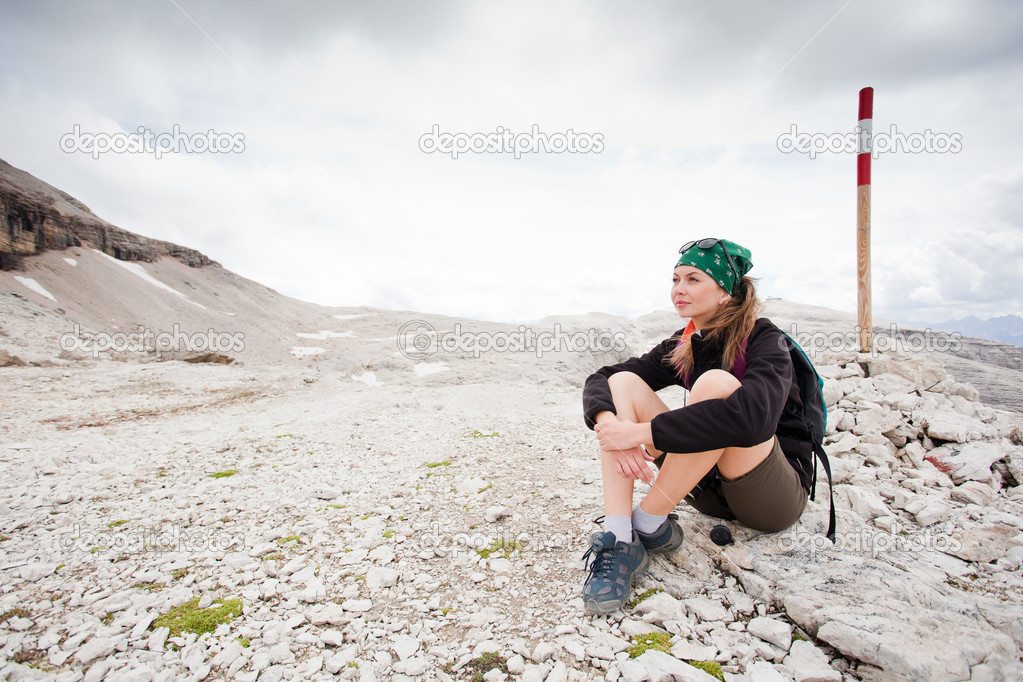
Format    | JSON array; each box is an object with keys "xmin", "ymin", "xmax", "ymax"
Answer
[{"xmin": 0, "ymin": 0, "xmax": 1023, "ymax": 322}]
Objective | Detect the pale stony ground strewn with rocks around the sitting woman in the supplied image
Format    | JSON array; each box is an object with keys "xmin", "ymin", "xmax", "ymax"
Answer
[{"xmin": 0, "ymin": 325, "xmax": 1023, "ymax": 680}]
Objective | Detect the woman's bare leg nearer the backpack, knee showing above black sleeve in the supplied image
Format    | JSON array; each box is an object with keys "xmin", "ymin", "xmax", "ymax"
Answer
[{"xmin": 642, "ymin": 369, "xmax": 774, "ymax": 515}]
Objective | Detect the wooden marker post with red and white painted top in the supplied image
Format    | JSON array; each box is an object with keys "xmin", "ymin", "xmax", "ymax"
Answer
[{"xmin": 856, "ymin": 88, "xmax": 874, "ymax": 353}]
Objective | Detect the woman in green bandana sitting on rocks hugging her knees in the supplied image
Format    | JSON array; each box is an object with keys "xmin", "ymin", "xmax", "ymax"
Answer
[{"xmin": 583, "ymin": 239, "xmax": 813, "ymax": 613}]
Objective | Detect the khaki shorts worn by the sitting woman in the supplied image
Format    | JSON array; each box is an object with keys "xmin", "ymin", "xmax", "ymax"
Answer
[{"xmin": 685, "ymin": 437, "xmax": 806, "ymax": 533}]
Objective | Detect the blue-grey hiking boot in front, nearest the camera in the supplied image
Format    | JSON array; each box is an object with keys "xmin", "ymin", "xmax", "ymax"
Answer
[{"xmin": 582, "ymin": 532, "xmax": 650, "ymax": 613}]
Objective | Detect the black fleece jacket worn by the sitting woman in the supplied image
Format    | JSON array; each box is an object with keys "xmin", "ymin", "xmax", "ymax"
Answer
[{"xmin": 582, "ymin": 318, "xmax": 813, "ymax": 491}]
